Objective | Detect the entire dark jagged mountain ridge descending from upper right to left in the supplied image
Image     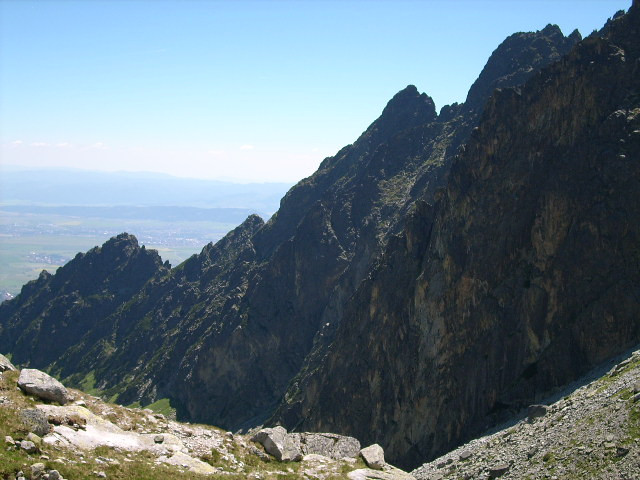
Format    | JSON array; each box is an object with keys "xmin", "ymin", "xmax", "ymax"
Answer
[{"xmin": 0, "ymin": 6, "xmax": 640, "ymax": 472}]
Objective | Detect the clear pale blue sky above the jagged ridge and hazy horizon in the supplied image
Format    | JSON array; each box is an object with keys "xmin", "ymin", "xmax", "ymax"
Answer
[{"xmin": 0, "ymin": 0, "xmax": 631, "ymax": 181}]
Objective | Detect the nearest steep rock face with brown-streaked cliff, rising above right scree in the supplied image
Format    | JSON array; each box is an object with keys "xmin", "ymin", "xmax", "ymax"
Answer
[{"xmin": 280, "ymin": 5, "xmax": 640, "ymax": 466}]
